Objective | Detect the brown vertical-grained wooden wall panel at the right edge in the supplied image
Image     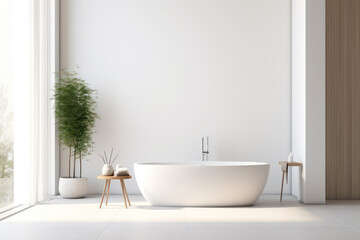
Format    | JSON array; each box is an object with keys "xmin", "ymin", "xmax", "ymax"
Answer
[{"xmin": 326, "ymin": 0, "xmax": 360, "ymax": 199}]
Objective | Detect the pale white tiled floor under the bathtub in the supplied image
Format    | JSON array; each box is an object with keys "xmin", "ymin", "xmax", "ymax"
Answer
[{"xmin": 0, "ymin": 195, "xmax": 360, "ymax": 240}]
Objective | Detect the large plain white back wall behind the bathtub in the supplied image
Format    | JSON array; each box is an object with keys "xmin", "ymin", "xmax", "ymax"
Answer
[{"xmin": 60, "ymin": 0, "xmax": 291, "ymax": 193}]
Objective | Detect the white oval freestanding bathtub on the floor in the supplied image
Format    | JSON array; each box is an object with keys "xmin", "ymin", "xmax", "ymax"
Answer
[{"xmin": 134, "ymin": 161, "xmax": 270, "ymax": 206}]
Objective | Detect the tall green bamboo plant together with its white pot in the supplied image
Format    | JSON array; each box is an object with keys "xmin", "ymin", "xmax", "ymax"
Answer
[{"xmin": 54, "ymin": 70, "xmax": 98, "ymax": 198}]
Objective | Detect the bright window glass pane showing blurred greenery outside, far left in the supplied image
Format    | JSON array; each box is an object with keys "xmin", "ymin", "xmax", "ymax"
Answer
[{"xmin": 0, "ymin": 0, "xmax": 14, "ymax": 209}]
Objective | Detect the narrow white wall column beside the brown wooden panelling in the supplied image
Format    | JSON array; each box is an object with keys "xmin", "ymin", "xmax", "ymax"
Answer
[{"xmin": 292, "ymin": 0, "xmax": 325, "ymax": 204}]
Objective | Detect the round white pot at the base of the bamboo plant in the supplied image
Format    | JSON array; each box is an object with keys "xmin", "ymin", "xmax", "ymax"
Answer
[{"xmin": 59, "ymin": 178, "xmax": 88, "ymax": 198}]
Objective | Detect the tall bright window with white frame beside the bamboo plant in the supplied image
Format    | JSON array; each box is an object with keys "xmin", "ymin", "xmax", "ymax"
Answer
[{"xmin": 0, "ymin": 0, "xmax": 59, "ymax": 218}]
